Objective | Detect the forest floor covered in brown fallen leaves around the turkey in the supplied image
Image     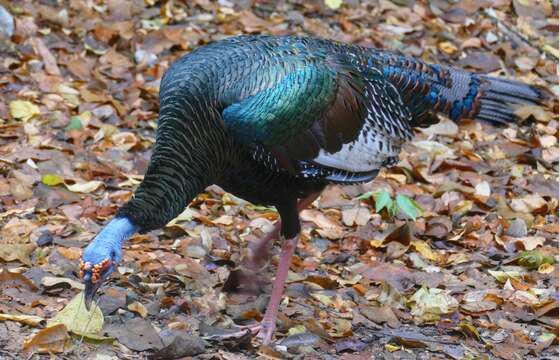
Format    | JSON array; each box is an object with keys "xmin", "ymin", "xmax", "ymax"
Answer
[{"xmin": 0, "ymin": 0, "xmax": 559, "ymax": 360}]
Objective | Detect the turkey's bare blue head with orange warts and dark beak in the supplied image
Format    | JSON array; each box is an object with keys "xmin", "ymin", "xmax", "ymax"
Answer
[{"xmin": 80, "ymin": 217, "xmax": 139, "ymax": 310}]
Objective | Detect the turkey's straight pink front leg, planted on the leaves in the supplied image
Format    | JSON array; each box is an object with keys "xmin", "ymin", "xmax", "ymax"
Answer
[{"xmin": 258, "ymin": 235, "xmax": 299, "ymax": 345}]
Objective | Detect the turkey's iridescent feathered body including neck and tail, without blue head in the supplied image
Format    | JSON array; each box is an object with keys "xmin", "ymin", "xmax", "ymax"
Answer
[{"xmin": 117, "ymin": 36, "xmax": 542, "ymax": 237}]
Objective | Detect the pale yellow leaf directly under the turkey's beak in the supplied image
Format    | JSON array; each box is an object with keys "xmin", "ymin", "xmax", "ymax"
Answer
[{"xmin": 47, "ymin": 292, "xmax": 103, "ymax": 335}]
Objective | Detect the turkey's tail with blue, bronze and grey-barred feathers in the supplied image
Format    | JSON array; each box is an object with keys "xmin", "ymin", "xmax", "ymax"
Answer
[{"xmin": 369, "ymin": 52, "xmax": 549, "ymax": 126}]
